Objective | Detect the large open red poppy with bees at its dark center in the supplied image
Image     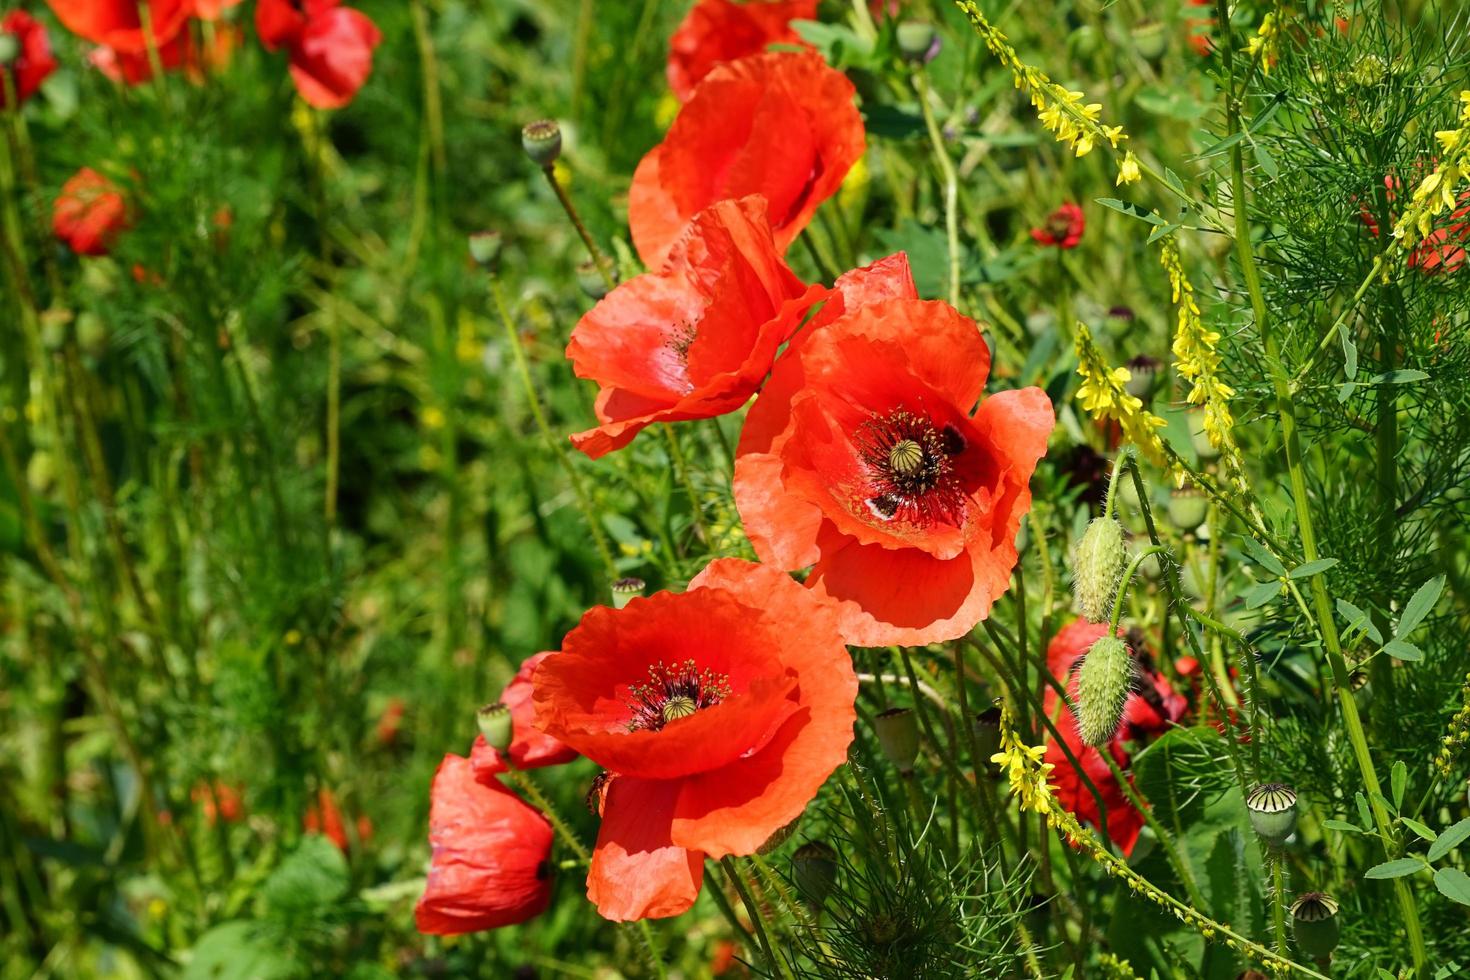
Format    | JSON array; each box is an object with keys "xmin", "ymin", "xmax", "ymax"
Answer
[{"xmin": 735, "ymin": 254, "xmax": 1055, "ymax": 646}]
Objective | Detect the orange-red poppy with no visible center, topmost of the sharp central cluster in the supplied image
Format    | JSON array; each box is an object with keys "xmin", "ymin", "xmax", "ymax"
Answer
[{"xmin": 628, "ymin": 51, "xmax": 864, "ymax": 269}]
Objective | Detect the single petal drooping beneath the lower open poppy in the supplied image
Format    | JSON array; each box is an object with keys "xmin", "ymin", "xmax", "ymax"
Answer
[{"xmin": 587, "ymin": 776, "xmax": 704, "ymax": 923}]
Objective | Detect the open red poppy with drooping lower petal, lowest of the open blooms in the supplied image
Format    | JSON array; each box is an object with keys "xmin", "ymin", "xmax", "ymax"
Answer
[{"xmin": 532, "ymin": 558, "xmax": 857, "ymax": 921}]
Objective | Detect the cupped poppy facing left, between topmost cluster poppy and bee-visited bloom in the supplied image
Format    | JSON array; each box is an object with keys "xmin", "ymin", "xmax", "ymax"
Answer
[{"xmin": 566, "ymin": 197, "xmax": 825, "ymax": 458}]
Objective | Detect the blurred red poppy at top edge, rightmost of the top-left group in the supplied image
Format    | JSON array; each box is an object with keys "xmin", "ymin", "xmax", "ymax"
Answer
[{"xmin": 256, "ymin": 0, "xmax": 382, "ymax": 109}]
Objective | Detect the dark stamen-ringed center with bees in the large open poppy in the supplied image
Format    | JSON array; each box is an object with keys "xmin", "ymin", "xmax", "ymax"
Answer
[{"xmin": 854, "ymin": 408, "xmax": 966, "ymax": 527}]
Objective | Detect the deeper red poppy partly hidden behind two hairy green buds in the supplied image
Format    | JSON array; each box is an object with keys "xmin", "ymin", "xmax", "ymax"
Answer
[{"xmin": 1044, "ymin": 619, "xmax": 1186, "ymax": 855}]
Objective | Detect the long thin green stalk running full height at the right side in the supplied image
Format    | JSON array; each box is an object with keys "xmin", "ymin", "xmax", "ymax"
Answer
[{"xmin": 1216, "ymin": 0, "xmax": 1429, "ymax": 976}]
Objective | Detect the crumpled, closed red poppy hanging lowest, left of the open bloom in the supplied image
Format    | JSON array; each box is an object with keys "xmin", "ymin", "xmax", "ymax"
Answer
[{"xmin": 413, "ymin": 755, "xmax": 551, "ymax": 936}]
